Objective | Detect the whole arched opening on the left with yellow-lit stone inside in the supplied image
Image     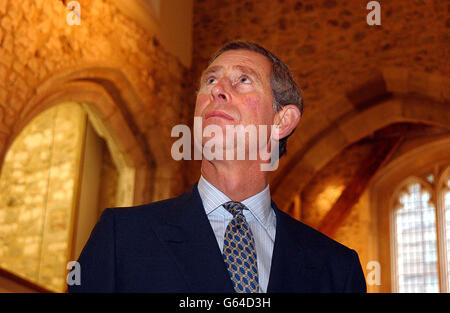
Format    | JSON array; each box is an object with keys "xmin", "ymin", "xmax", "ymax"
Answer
[{"xmin": 0, "ymin": 102, "xmax": 134, "ymax": 292}]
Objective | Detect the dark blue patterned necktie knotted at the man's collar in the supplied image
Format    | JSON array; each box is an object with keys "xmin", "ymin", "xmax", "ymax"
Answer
[{"xmin": 223, "ymin": 201, "xmax": 259, "ymax": 293}]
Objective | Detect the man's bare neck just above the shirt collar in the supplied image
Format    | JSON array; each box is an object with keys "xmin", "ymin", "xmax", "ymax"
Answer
[{"xmin": 201, "ymin": 160, "xmax": 269, "ymax": 201}]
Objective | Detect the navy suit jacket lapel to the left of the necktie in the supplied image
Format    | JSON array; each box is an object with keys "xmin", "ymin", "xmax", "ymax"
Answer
[{"xmin": 157, "ymin": 183, "xmax": 234, "ymax": 293}]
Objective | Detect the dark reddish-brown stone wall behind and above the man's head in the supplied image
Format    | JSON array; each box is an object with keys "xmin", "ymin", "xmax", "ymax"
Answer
[{"xmin": 193, "ymin": 0, "xmax": 450, "ymax": 106}]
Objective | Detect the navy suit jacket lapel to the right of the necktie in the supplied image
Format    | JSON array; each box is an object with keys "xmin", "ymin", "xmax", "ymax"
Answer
[{"xmin": 267, "ymin": 202, "xmax": 319, "ymax": 292}]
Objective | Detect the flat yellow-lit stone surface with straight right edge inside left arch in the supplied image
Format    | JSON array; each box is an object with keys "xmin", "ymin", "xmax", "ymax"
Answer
[{"xmin": 0, "ymin": 104, "xmax": 86, "ymax": 291}]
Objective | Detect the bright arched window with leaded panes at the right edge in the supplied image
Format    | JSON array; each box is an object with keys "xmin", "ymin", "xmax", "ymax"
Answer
[{"xmin": 391, "ymin": 168, "xmax": 450, "ymax": 292}]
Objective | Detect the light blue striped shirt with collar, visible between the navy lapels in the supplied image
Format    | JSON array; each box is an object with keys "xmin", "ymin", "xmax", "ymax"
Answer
[{"xmin": 198, "ymin": 176, "xmax": 276, "ymax": 292}]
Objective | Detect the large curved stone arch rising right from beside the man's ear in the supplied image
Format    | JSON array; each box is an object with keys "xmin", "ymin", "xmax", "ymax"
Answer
[{"xmin": 272, "ymin": 68, "xmax": 450, "ymax": 210}]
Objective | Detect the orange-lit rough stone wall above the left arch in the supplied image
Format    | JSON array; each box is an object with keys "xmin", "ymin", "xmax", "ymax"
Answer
[{"xmin": 0, "ymin": 0, "xmax": 191, "ymax": 200}]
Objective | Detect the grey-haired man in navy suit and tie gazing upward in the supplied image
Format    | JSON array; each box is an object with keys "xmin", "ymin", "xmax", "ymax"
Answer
[{"xmin": 69, "ymin": 41, "xmax": 366, "ymax": 292}]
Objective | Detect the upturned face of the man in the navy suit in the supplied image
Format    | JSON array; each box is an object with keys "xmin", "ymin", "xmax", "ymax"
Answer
[{"xmin": 194, "ymin": 50, "xmax": 275, "ymax": 152}]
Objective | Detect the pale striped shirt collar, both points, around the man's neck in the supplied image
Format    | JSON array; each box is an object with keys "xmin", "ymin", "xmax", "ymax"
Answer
[{"xmin": 197, "ymin": 176, "xmax": 272, "ymax": 226}]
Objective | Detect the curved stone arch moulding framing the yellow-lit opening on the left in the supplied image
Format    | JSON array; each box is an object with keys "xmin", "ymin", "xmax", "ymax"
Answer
[{"xmin": 0, "ymin": 66, "xmax": 162, "ymax": 204}]
